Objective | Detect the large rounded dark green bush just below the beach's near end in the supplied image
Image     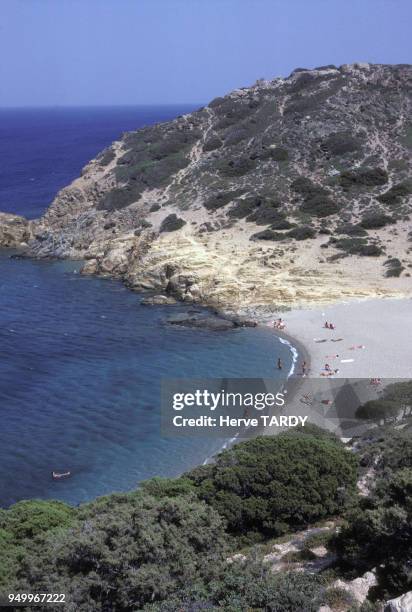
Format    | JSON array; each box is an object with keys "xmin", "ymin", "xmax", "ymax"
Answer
[{"xmin": 186, "ymin": 432, "xmax": 356, "ymax": 535}]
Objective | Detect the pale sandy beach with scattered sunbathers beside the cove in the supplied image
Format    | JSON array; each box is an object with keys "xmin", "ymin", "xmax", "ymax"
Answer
[{"xmin": 260, "ymin": 297, "xmax": 412, "ymax": 438}]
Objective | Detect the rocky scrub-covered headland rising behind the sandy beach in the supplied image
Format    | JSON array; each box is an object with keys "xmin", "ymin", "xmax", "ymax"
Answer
[{"xmin": 15, "ymin": 64, "xmax": 412, "ymax": 312}]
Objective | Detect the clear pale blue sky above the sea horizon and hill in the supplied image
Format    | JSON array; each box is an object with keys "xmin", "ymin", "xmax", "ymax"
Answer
[{"xmin": 0, "ymin": 0, "xmax": 412, "ymax": 106}]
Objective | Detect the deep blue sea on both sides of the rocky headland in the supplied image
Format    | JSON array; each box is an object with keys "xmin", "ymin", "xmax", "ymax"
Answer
[{"xmin": 0, "ymin": 107, "xmax": 292, "ymax": 506}]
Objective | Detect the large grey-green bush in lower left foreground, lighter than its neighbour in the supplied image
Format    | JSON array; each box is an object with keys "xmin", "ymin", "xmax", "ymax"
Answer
[{"xmin": 18, "ymin": 494, "xmax": 226, "ymax": 611}]
